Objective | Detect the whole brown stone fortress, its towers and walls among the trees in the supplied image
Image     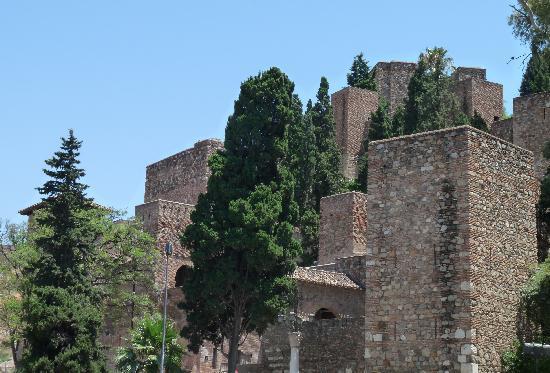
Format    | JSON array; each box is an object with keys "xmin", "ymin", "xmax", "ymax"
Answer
[{"xmin": 125, "ymin": 62, "xmax": 550, "ymax": 373}]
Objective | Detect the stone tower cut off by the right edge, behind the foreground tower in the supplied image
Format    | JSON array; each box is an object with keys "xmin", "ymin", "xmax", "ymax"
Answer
[{"xmin": 514, "ymin": 93, "xmax": 550, "ymax": 179}]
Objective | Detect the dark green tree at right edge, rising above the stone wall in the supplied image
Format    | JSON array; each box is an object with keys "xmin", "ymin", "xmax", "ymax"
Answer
[{"xmin": 519, "ymin": 46, "xmax": 550, "ymax": 96}]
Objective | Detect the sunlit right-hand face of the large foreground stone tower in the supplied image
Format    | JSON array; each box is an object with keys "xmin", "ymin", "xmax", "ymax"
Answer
[{"xmin": 463, "ymin": 132, "xmax": 539, "ymax": 372}]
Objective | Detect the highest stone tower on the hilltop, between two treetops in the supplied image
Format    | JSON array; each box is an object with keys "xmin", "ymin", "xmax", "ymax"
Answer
[{"xmin": 374, "ymin": 61, "xmax": 416, "ymax": 114}]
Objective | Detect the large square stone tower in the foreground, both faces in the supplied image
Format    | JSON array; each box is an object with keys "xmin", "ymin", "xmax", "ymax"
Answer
[{"xmin": 365, "ymin": 127, "xmax": 536, "ymax": 372}]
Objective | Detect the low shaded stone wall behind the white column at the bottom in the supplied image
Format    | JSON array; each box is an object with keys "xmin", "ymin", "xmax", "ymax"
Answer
[{"xmin": 253, "ymin": 318, "xmax": 365, "ymax": 373}]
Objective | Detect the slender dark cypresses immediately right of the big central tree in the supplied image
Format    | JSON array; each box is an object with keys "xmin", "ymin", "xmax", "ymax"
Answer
[{"xmin": 287, "ymin": 77, "xmax": 344, "ymax": 265}]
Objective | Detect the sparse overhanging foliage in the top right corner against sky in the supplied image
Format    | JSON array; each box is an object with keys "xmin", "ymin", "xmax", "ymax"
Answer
[{"xmin": 508, "ymin": 0, "xmax": 550, "ymax": 47}]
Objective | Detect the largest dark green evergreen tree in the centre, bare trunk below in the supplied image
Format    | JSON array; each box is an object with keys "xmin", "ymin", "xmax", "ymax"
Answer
[{"xmin": 181, "ymin": 68, "xmax": 301, "ymax": 373}]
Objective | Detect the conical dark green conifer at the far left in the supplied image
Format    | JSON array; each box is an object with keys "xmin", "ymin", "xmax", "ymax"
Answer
[{"xmin": 22, "ymin": 131, "xmax": 105, "ymax": 372}]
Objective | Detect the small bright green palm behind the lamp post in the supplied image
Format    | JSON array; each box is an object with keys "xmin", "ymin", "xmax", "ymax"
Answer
[{"xmin": 116, "ymin": 313, "xmax": 183, "ymax": 373}]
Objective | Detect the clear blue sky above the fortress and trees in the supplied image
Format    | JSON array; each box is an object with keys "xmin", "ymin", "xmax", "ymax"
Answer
[{"xmin": 0, "ymin": 0, "xmax": 526, "ymax": 221}]
